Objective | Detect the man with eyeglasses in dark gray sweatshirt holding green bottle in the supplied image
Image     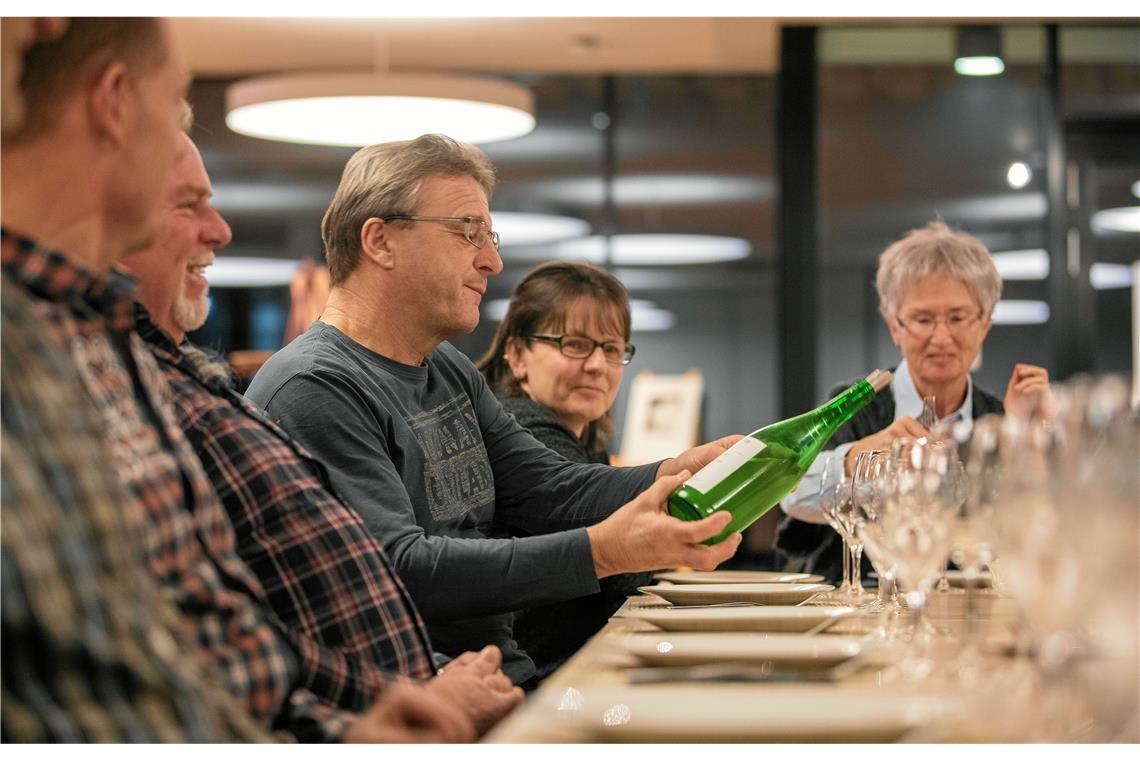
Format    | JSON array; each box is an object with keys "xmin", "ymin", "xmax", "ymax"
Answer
[{"xmin": 247, "ymin": 134, "xmax": 740, "ymax": 688}]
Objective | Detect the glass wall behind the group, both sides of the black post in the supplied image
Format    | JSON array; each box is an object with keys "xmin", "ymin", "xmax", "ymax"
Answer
[{"xmin": 184, "ymin": 22, "xmax": 1140, "ymax": 558}]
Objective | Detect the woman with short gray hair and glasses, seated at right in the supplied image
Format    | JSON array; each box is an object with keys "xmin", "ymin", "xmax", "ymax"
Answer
[{"xmin": 776, "ymin": 221, "xmax": 1050, "ymax": 580}]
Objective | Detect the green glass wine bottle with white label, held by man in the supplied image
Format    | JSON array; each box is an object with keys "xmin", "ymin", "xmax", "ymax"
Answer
[{"xmin": 669, "ymin": 369, "xmax": 891, "ymax": 544}]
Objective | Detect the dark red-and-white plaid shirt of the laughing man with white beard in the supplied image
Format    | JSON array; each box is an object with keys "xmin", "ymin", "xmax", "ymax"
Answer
[{"xmin": 136, "ymin": 305, "xmax": 434, "ymax": 678}]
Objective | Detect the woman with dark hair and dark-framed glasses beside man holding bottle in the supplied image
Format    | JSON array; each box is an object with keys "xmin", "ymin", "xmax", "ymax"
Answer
[{"xmin": 475, "ymin": 261, "xmax": 651, "ymax": 678}]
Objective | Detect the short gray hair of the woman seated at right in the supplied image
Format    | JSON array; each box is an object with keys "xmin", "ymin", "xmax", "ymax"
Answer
[{"xmin": 874, "ymin": 221, "xmax": 1001, "ymax": 318}]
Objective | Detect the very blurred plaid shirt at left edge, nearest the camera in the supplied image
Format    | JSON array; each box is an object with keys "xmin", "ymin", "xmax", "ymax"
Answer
[{"xmin": 0, "ymin": 272, "xmax": 268, "ymax": 742}]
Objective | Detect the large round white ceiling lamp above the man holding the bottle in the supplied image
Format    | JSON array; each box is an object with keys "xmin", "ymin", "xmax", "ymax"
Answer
[{"xmin": 226, "ymin": 73, "xmax": 535, "ymax": 147}]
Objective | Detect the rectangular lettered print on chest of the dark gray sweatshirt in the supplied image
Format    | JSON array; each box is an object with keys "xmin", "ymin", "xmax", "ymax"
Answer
[{"xmin": 407, "ymin": 393, "xmax": 495, "ymax": 522}]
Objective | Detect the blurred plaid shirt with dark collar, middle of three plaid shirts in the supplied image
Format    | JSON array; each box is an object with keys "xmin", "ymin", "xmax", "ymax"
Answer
[{"xmin": 0, "ymin": 231, "xmax": 360, "ymax": 741}]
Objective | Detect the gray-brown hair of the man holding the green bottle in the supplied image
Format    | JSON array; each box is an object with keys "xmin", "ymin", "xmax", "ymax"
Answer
[{"xmin": 320, "ymin": 134, "xmax": 495, "ymax": 285}]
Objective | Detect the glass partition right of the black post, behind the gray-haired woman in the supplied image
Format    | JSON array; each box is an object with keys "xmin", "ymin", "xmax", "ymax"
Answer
[{"xmin": 816, "ymin": 24, "xmax": 1140, "ymax": 397}]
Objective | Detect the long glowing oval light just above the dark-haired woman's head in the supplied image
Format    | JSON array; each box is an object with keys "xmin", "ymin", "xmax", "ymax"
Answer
[{"xmin": 553, "ymin": 234, "xmax": 751, "ymax": 267}]
